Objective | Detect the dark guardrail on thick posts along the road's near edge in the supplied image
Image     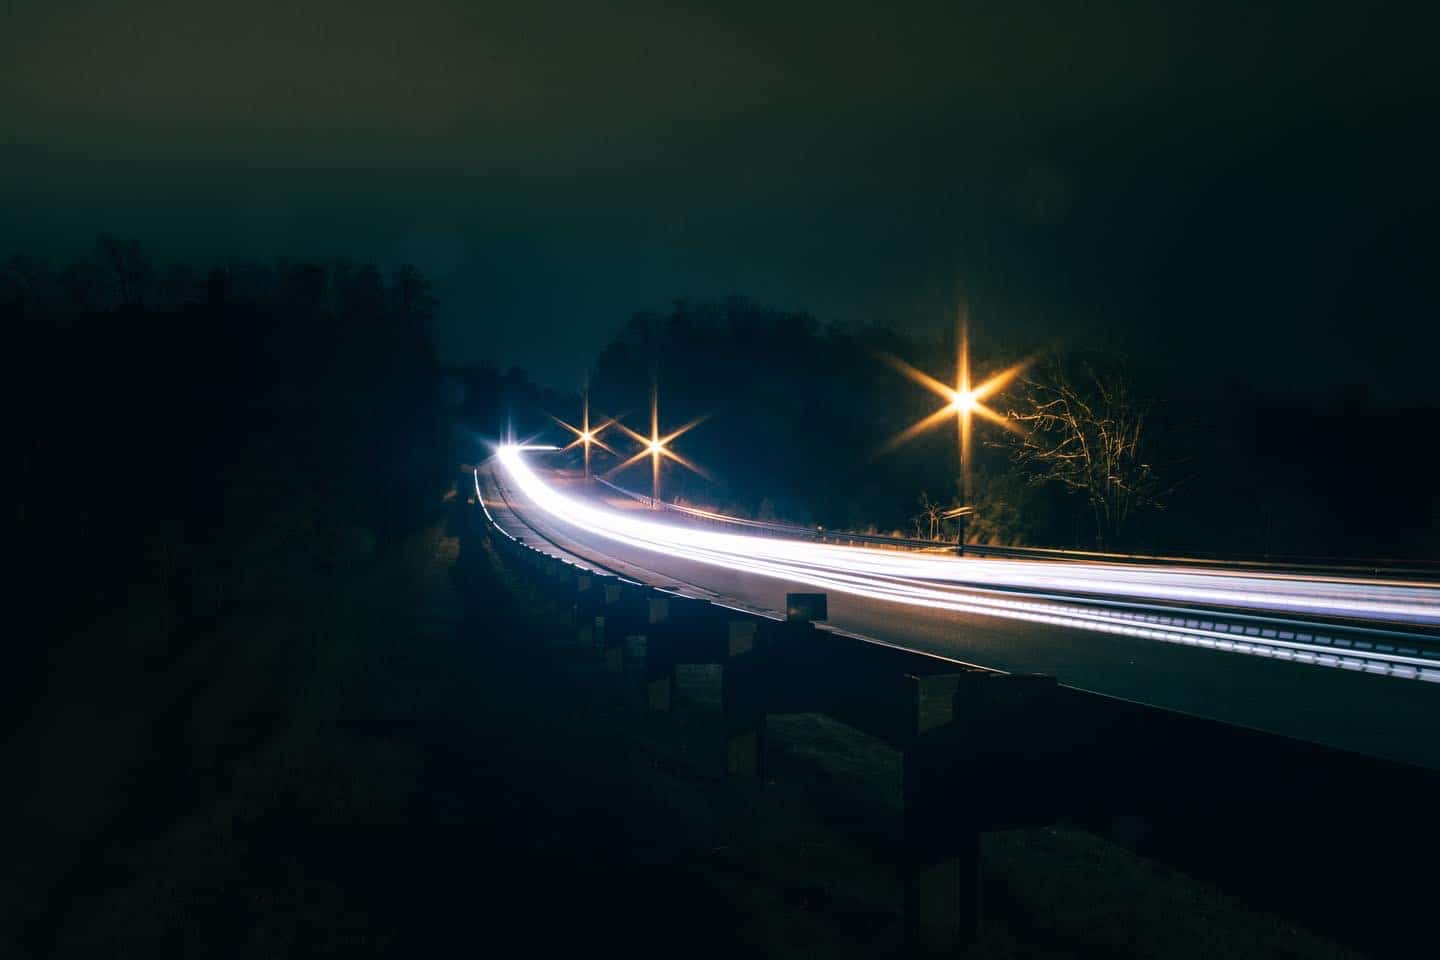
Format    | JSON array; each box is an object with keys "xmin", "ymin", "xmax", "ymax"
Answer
[{"xmin": 477, "ymin": 477, "xmax": 1440, "ymax": 956}]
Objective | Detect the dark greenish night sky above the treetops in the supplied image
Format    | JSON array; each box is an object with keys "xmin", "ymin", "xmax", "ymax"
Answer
[{"xmin": 0, "ymin": 0, "xmax": 1440, "ymax": 399}]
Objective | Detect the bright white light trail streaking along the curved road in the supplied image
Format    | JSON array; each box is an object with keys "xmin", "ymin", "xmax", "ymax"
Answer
[{"xmin": 498, "ymin": 446, "xmax": 1440, "ymax": 681}]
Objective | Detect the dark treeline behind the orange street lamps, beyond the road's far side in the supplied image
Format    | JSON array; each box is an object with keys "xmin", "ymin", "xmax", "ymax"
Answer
[{"xmin": 498, "ymin": 298, "xmax": 1440, "ymax": 558}]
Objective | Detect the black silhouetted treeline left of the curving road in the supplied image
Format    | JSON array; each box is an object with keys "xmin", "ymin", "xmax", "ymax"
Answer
[{"xmin": 0, "ymin": 236, "xmax": 446, "ymax": 711}]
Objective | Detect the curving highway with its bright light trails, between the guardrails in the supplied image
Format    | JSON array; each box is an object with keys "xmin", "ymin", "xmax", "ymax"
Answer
[{"xmin": 477, "ymin": 448, "xmax": 1440, "ymax": 769}]
